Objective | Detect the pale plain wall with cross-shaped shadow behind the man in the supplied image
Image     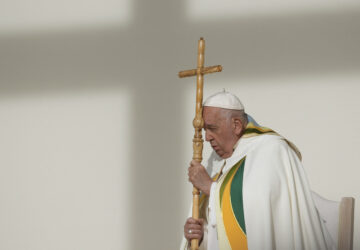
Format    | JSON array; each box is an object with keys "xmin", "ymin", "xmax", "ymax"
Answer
[{"xmin": 0, "ymin": 0, "xmax": 360, "ymax": 250}]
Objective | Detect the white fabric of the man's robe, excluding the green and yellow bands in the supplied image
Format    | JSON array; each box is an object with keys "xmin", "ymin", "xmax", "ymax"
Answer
[{"xmin": 181, "ymin": 134, "xmax": 336, "ymax": 250}]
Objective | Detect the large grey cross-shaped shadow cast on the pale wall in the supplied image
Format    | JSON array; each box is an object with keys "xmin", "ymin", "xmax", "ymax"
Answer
[{"xmin": 0, "ymin": 0, "xmax": 360, "ymax": 249}]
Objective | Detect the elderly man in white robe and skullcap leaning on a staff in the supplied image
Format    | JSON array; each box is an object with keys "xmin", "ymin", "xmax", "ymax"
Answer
[{"xmin": 181, "ymin": 91, "xmax": 335, "ymax": 250}]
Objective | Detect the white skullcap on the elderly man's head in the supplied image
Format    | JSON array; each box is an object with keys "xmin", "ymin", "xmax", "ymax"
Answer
[{"xmin": 203, "ymin": 89, "xmax": 244, "ymax": 110}]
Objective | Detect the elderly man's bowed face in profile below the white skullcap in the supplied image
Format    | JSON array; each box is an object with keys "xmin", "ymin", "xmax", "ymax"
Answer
[{"xmin": 203, "ymin": 107, "xmax": 238, "ymax": 159}]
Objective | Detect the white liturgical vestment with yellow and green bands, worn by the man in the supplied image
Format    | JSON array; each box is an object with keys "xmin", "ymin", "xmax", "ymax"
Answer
[{"xmin": 181, "ymin": 116, "xmax": 336, "ymax": 250}]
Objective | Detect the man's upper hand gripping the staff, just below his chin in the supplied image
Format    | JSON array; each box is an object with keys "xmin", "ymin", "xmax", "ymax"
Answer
[{"xmin": 188, "ymin": 160, "xmax": 213, "ymax": 196}]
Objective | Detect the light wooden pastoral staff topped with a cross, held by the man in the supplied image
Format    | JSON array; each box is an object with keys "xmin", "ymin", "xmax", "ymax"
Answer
[{"xmin": 179, "ymin": 37, "xmax": 222, "ymax": 250}]
